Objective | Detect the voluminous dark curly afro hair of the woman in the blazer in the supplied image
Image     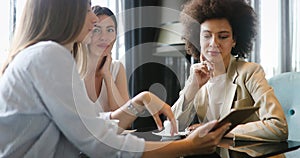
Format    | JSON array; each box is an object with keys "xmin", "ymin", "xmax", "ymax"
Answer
[{"xmin": 180, "ymin": 0, "xmax": 257, "ymax": 59}]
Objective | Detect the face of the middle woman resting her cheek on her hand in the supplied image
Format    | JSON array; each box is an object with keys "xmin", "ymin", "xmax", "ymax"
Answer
[{"xmin": 90, "ymin": 15, "xmax": 116, "ymax": 55}]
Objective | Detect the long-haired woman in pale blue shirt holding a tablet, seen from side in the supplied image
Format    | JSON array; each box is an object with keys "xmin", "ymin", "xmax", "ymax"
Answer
[{"xmin": 0, "ymin": 0, "xmax": 228, "ymax": 158}]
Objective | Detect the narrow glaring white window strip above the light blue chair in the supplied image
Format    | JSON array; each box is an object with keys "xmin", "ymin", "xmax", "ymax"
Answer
[{"xmin": 259, "ymin": 0, "xmax": 281, "ymax": 78}]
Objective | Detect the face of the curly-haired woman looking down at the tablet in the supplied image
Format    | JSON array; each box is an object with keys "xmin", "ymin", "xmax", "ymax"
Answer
[{"xmin": 200, "ymin": 19, "xmax": 235, "ymax": 69}]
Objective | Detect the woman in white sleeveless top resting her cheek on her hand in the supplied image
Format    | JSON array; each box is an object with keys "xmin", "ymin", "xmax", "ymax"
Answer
[{"xmin": 76, "ymin": 6, "xmax": 129, "ymax": 111}]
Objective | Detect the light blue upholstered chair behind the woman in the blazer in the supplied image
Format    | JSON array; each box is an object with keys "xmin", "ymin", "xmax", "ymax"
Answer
[{"xmin": 268, "ymin": 72, "xmax": 300, "ymax": 157}]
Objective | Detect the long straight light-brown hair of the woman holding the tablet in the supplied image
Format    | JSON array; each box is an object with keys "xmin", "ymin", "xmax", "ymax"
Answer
[{"xmin": 0, "ymin": 0, "xmax": 90, "ymax": 76}]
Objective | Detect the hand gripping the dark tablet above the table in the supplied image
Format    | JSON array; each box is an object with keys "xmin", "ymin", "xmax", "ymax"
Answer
[{"xmin": 185, "ymin": 121, "xmax": 230, "ymax": 154}]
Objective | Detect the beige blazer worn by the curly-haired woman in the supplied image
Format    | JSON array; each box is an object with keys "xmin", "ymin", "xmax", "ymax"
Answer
[{"xmin": 172, "ymin": 57, "xmax": 288, "ymax": 141}]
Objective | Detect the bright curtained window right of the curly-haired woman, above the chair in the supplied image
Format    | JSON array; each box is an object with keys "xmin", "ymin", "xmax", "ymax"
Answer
[{"xmin": 251, "ymin": 0, "xmax": 300, "ymax": 78}]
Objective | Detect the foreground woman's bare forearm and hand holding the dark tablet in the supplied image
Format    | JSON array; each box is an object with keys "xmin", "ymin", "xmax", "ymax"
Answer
[{"xmin": 142, "ymin": 121, "xmax": 230, "ymax": 158}]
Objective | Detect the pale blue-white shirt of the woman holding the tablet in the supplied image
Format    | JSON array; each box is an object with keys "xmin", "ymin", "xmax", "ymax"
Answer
[{"xmin": 0, "ymin": 41, "xmax": 145, "ymax": 158}]
